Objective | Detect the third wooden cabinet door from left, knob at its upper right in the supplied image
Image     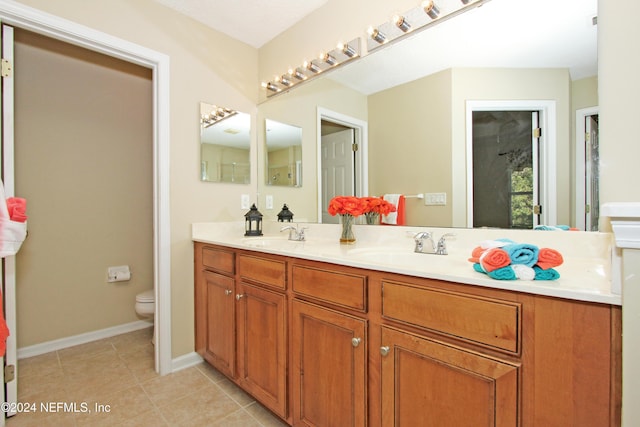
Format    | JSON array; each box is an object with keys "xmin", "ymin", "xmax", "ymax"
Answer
[{"xmin": 292, "ymin": 300, "xmax": 367, "ymax": 426}]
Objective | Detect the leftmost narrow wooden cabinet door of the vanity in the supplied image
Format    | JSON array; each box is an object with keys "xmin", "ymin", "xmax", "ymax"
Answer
[{"xmin": 204, "ymin": 271, "xmax": 235, "ymax": 377}]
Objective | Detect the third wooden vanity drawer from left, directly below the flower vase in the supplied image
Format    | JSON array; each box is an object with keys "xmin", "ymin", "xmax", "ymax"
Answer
[{"xmin": 292, "ymin": 265, "xmax": 367, "ymax": 312}]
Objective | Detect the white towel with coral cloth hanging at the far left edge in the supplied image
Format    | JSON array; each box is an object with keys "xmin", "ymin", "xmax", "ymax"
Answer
[{"xmin": 0, "ymin": 181, "xmax": 27, "ymax": 258}]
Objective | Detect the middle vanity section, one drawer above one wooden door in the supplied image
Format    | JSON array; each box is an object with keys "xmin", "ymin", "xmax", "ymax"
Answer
[{"xmin": 291, "ymin": 262, "xmax": 368, "ymax": 426}]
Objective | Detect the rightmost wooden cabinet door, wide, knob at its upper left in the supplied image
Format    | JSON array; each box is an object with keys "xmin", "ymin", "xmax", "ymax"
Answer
[{"xmin": 380, "ymin": 327, "xmax": 519, "ymax": 427}]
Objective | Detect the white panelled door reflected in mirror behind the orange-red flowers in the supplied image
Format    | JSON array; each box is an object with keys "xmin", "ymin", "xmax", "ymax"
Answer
[{"xmin": 320, "ymin": 129, "xmax": 355, "ymax": 224}]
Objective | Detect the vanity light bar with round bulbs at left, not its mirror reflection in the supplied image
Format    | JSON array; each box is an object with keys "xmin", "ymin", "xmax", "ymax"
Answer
[{"xmin": 262, "ymin": 38, "xmax": 360, "ymax": 97}]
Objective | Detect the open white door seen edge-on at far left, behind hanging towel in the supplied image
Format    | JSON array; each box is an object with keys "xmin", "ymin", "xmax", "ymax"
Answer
[{"xmin": 0, "ymin": 25, "xmax": 18, "ymax": 425}]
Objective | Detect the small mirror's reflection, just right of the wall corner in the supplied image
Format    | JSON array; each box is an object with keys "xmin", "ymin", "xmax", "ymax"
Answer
[{"xmin": 265, "ymin": 119, "xmax": 302, "ymax": 187}]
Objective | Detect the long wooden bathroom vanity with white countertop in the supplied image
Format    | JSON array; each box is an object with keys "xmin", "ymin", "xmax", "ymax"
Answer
[{"xmin": 193, "ymin": 223, "xmax": 621, "ymax": 426}]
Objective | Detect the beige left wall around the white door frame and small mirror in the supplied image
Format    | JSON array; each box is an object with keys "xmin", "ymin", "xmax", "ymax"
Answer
[{"xmin": 12, "ymin": 0, "xmax": 259, "ymax": 357}]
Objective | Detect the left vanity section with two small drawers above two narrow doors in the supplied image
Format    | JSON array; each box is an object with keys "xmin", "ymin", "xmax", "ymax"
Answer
[{"xmin": 194, "ymin": 246, "xmax": 288, "ymax": 419}]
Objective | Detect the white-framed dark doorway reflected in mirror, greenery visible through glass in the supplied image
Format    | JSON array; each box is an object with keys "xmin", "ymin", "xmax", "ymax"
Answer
[{"xmin": 466, "ymin": 100, "xmax": 556, "ymax": 229}]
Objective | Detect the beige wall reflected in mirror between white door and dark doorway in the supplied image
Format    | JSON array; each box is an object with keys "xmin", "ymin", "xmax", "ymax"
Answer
[{"xmin": 369, "ymin": 70, "xmax": 453, "ymax": 226}]
